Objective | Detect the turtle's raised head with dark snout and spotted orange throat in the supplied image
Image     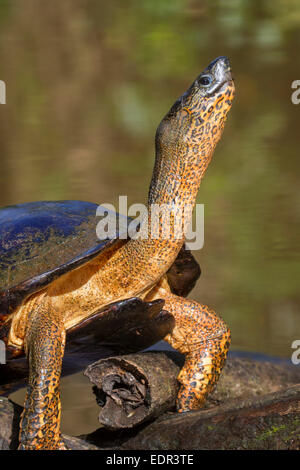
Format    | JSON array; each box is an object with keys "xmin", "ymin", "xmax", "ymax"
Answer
[{"xmin": 156, "ymin": 56, "xmax": 234, "ymax": 184}]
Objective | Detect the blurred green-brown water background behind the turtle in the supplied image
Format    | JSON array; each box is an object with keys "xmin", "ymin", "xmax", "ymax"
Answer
[{"xmin": 0, "ymin": 0, "xmax": 300, "ymax": 432}]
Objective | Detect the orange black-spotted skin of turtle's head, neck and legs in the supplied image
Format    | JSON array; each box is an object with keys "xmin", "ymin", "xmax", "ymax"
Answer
[{"xmin": 9, "ymin": 58, "xmax": 234, "ymax": 449}]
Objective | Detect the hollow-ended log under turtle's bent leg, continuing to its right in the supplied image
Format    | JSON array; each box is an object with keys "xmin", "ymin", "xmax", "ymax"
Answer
[{"xmin": 84, "ymin": 352, "xmax": 300, "ymax": 429}]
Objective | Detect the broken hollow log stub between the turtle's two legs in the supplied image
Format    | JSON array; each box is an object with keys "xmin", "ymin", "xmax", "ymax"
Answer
[{"xmin": 84, "ymin": 352, "xmax": 180, "ymax": 429}]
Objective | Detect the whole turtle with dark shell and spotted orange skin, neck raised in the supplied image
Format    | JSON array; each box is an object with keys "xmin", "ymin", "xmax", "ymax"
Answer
[{"xmin": 0, "ymin": 56, "xmax": 234, "ymax": 449}]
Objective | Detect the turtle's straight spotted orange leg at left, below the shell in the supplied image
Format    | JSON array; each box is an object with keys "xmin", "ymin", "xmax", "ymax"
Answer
[{"xmin": 19, "ymin": 305, "xmax": 66, "ymax": 450}]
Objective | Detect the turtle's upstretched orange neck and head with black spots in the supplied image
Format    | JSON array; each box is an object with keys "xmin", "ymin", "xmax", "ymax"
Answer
[{"xmin": 56, "ymin": 67, "xmax": 234, "ymax": 311}]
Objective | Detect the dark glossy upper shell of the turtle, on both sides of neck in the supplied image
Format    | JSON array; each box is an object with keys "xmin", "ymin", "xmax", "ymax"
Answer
[{"xmin": 0, "ymin": 201, "xmax": 200, "ymax": 360}]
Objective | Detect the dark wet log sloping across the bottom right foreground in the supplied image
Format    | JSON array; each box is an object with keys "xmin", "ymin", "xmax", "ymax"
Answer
[{"xmin": 119, "ymin": 385, "xmax": 300, "ymax": 450}]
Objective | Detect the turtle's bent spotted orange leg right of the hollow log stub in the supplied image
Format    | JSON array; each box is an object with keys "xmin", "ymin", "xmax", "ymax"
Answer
[{"xmin": 147, "ymin": 286, "xmax": 230, "ymax": 411}]
